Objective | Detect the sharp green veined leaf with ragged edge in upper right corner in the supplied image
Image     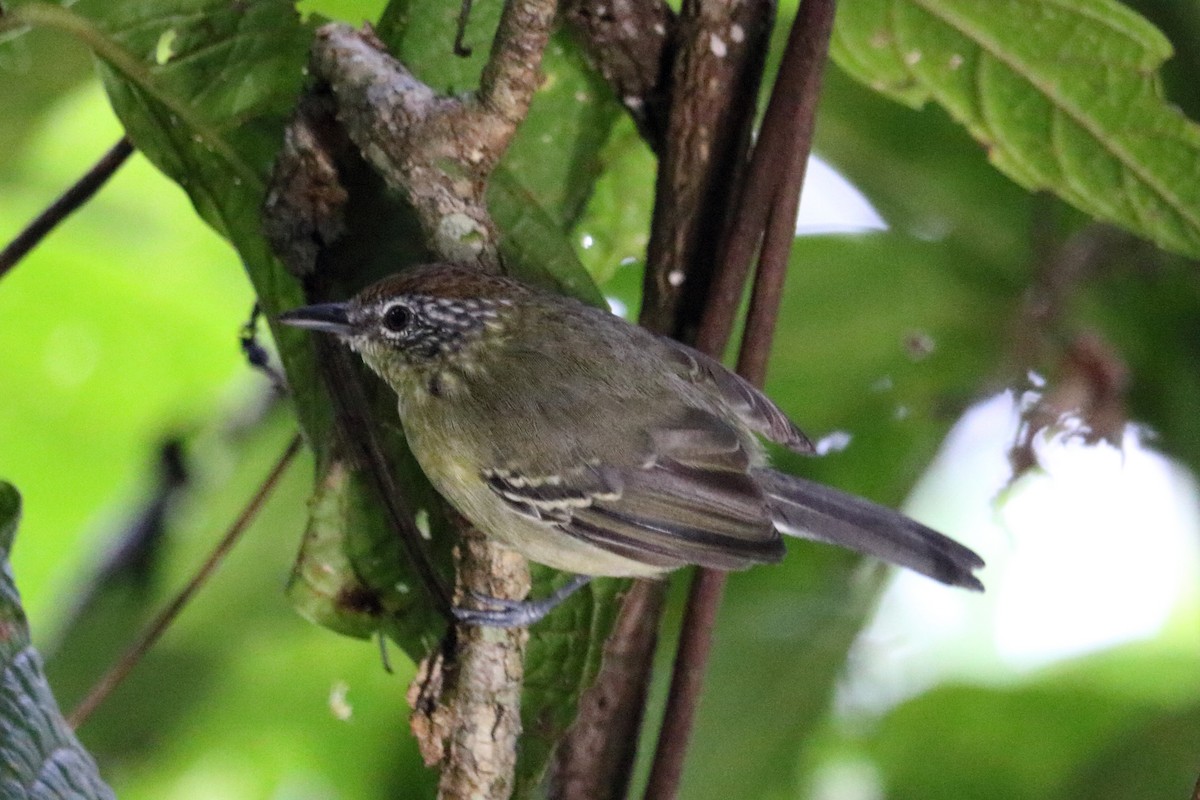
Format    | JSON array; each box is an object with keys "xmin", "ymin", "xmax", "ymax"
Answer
[{"xmin": 832, "ymin": 0, "xmax": 1200, "ymax": 255}]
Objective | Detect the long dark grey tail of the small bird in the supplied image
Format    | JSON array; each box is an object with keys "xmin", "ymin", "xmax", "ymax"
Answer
[{"xmin": 755, "ymin": 469, "xmax": 983, "ymax": 591}]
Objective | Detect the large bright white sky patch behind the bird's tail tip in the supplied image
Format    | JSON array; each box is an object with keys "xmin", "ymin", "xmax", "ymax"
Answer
[{"xmin": 839, "ymin": 393, "xmax": 1200, "ymax": 714}]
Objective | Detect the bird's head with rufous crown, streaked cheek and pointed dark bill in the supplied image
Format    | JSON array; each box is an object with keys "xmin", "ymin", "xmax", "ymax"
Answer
[{"xmin": 278, "ymin": 264, "xmax": 530, "ymax": 386}]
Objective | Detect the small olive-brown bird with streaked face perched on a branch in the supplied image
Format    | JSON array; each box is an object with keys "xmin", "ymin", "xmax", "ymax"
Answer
[{"xmin": 278, "ymin": 264, "xmax": 983, "ymax": 626}]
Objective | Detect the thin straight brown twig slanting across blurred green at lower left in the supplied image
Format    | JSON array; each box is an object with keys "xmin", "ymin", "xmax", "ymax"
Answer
[{"xmin": 67, "ymin": 435, "xmax": 300, "ymax": 728}]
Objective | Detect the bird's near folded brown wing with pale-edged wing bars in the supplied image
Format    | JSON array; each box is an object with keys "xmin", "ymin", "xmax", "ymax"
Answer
[{"xmin": 484, "ymin": 409, "xmax": 784, "ymax": 570}]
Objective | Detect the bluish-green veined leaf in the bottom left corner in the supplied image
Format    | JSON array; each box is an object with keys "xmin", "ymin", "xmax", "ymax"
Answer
[{"xmin": 0, "ymin": 482, "xmax": 115, "ymax": 800}]
